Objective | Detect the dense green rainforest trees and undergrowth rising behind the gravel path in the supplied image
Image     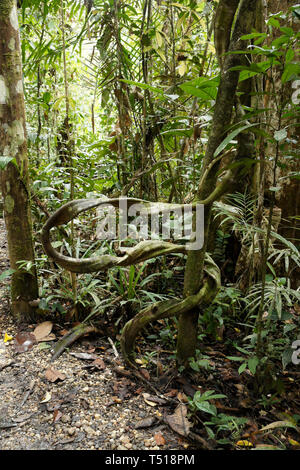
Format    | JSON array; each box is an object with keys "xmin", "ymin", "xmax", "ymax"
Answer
[{"xmin": 0, "ymin": 0, "xmax": 300, "ymax": 449}]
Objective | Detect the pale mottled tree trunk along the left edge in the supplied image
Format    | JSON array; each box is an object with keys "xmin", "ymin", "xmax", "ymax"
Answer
[{"xmin": 0, "ymin": 0, "xmax": 38, "ymax": 317}]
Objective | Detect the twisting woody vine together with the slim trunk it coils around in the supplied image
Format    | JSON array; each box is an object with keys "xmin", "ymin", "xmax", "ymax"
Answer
[{"xmin": 43, "ymin": 0, "xmax": 260, "ymax": 364}]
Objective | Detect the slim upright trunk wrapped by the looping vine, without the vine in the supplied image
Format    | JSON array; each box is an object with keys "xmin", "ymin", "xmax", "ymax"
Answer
[{"xmin": 177, "ymin": 0, "xmax": 258, "ymax": 365}]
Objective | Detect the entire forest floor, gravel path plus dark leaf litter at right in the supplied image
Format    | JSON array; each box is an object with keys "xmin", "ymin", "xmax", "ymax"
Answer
[{"xmin": 0, "ymin": 218, "xmax": 300, "ymax": 451}]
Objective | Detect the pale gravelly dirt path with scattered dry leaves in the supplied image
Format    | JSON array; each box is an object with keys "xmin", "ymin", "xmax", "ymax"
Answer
[{"xmin": 0, "ymin": 218, "xmax": 188, "ymax": 450}]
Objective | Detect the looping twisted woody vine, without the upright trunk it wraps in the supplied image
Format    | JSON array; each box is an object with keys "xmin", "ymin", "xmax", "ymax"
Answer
[{"xmin": 42, "ymin": 198, "xmax": 221, "ymax": 367}]
